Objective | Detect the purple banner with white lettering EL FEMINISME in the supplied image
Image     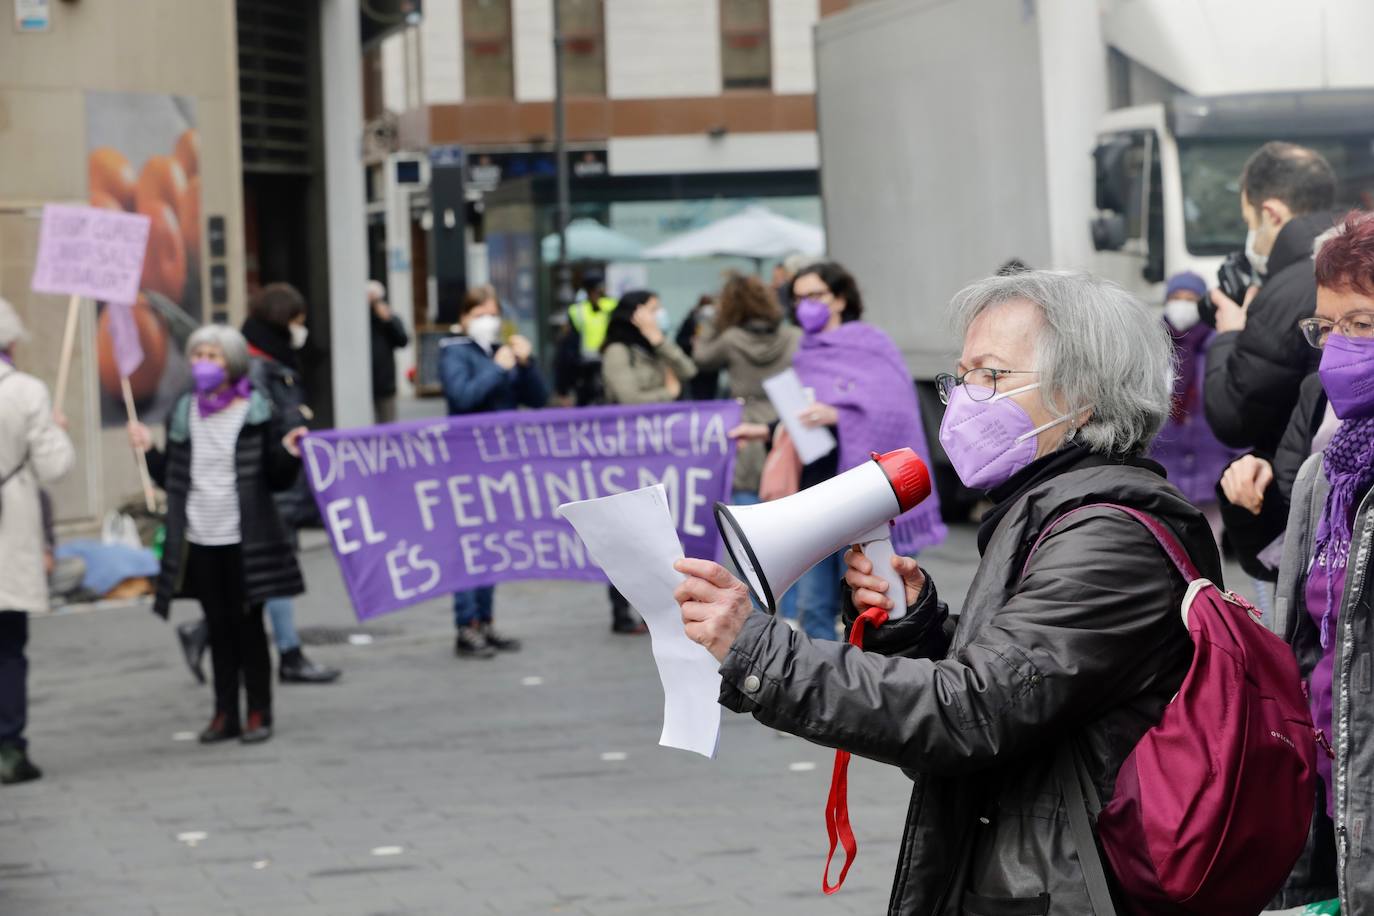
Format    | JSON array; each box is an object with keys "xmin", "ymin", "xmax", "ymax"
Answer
[{"xmin": 302, "ymin": 401, "xmax": 741, "ymax": 619}]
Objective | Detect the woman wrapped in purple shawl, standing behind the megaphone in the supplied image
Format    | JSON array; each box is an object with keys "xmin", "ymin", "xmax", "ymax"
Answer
[{"xmin": 791, "ymin": 261, "xmax": 945, "ymax": 640}]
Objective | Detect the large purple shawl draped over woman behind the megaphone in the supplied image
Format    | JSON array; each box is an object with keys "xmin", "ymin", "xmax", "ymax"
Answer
[{"xmin": 793, "ymin": 321, "xmax": 947, "ymax": 553}]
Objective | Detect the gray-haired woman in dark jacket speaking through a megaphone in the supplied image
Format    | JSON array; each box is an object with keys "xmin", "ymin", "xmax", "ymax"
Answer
[{"xmin": 677, "ymin": 271, "xmax": 1221, "ymax": 916}]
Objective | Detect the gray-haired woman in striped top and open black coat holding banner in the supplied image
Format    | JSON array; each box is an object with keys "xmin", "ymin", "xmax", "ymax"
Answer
[{"xmin": 129, "ymin": 324, "xmax": 305, "ymax": 744}]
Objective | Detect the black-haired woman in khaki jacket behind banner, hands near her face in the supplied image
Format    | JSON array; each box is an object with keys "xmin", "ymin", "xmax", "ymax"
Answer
[{"xmin": 602, "ymin": 290, "xmax": 697, "ymax": 634}]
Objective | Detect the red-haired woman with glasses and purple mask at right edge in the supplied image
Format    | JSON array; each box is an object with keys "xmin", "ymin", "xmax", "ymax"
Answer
[{"xmin": 1253, "ymin": 213, "xmax": 1374, "ymax": 913}]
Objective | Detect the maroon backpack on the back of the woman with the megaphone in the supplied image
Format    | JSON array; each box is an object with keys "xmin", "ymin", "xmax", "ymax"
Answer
[{"xmin": 1022, "ymin": 503, "xmax": 1320, "ymax": 916}]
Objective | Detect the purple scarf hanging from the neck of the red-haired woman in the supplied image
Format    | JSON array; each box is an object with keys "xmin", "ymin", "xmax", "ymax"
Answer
[{"xmin": 1312, "ymin": 416, "xmax": 1374, "ymax": 648}]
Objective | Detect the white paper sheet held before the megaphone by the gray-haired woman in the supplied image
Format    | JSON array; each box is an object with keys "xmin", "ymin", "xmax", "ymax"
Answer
[{"xmin": 558, "ymin": 483, "xmax": 720, "ymax": 757}]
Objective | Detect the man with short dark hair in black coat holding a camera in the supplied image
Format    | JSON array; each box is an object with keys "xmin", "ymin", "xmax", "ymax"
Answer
[{"xmin": 1204, "ymin": 143, "xmax": 1336, "ymax": 457}]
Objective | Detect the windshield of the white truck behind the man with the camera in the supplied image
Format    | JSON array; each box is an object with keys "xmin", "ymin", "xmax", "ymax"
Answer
[{"xmin": 1179, "ymin": 133, "xmax": 1374, "ymax": 255}]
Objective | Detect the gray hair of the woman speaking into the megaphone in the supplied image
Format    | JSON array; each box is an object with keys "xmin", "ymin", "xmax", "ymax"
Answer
[{"xmin": 951, "ymin": 271, "xmax": 1175, "ymax": 455}]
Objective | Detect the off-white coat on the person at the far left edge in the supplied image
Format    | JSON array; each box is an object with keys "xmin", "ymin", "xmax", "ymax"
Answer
[{"xmin": 0, "ymin": 363, "xmax": 76, "ymax": 612}]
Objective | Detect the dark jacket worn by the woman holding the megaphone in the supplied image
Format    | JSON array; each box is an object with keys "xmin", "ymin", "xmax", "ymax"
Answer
[{"xmin": 721, "ymin": 459, "xmax": 1221, "ymax": 916}]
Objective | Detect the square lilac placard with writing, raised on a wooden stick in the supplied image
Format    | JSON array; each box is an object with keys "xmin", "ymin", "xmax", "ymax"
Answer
[{"xmin": 30, "ymin": 203, "xmax": 151, "ymax": 302}]
